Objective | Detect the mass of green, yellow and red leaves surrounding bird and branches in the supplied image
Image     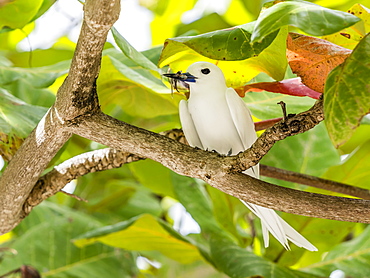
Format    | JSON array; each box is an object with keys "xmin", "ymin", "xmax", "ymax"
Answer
[{"xmin": 0, "ymin": 0, "xmax": 370, "ymax": 277}]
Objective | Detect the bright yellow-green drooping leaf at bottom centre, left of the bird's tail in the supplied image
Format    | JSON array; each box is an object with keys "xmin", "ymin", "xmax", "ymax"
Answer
[{"xmin": 74, "ymin": 214, "xmax": 202, "ymax": 263}]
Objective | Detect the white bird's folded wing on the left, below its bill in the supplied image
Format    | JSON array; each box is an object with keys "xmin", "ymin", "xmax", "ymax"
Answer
[{"xmin": 179, "ymin": 100, "xmax": 203, "ymax": 149}]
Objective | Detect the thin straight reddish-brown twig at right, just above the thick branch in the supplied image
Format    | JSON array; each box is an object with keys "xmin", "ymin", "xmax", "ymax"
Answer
[{"xmin": 260, "ymin": 165, "xmax": 370, "ymax": 200}]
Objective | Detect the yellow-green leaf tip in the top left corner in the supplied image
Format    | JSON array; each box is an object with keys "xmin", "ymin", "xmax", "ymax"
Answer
[{"xmin": 0, "ymin": 0, "xmax": 44, "ymax": 29}]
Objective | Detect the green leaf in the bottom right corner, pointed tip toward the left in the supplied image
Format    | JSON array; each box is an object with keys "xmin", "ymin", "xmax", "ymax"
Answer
[{"xmin": 304, "ymin": 226, "xmax": 370, "ymax": 277}]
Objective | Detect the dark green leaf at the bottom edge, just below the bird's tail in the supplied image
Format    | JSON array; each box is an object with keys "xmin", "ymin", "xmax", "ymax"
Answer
[{"xmin": 210, "ymin": 237, "xmax": 317, "ymax": 278}]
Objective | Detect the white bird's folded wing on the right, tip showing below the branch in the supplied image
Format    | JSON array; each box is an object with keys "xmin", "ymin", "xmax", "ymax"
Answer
[{"xmin": 226, "ymin": 88, "xmax": 259, "ymax": 178}]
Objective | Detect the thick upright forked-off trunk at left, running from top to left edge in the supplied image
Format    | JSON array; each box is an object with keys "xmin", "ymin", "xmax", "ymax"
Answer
[{"xmin": 0, "ymin": 0, "xmax": 120, "ymax": 234}]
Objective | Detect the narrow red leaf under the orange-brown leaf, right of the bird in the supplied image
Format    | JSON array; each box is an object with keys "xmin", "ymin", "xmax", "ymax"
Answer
[{"xmin": 235, "ymin": 77, "xmax": 321, "ymax": 99}]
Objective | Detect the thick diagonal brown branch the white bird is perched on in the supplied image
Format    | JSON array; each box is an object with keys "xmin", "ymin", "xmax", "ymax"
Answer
[{"xmin": 67, "ymin": 111, "xmax": 370, "ymax": 223}]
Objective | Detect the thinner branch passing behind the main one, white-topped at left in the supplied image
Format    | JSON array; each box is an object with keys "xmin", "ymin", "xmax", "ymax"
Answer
[{"xmin": 23, "ymin": 129, "xmax": 370, "ymax": 214}]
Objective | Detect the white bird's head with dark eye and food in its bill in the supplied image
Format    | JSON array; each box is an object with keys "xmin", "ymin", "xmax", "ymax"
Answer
[{"xmin": 163, "ymin": 62, "xmax": 226, "ymax": 97}]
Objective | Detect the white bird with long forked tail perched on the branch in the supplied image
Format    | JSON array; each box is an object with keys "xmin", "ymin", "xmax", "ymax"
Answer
[{"xmin": 164, "ymin": 62, "xmax": 317, "ymax": 251}]
